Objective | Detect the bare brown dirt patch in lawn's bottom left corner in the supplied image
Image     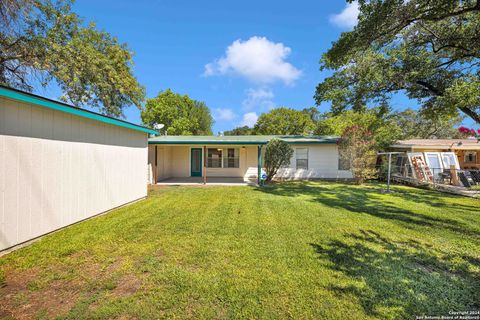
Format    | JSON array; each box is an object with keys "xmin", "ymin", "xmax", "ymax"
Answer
[{"xmin": 0, "ymin": 252, "xmax": 142, "ymax": 319}]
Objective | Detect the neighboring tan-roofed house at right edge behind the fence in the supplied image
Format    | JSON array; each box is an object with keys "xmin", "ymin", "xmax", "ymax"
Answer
[{"xmin": 390, "ymin": 139, "xmax": 480, "ymax": 169}]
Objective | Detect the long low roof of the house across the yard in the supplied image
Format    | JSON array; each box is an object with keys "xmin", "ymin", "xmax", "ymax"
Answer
[{"xmin": 148, "ymin": 135, "xmax": 338, "ymax": 145}]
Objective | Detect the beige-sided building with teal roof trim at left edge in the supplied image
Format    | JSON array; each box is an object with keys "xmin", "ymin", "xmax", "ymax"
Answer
[{"xmin": 0, "ymin": 86, "xmax": 157, "ymax": 250}]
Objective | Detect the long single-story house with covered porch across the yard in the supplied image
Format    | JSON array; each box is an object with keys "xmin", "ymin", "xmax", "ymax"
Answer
[{"xmin": 148, "ymin": 136, "xmax": 352, "ymax": 182}]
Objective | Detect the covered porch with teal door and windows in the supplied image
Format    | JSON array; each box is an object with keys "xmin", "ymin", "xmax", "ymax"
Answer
[{"xmin": 149, "ymin": 136, "xmax": 266, "ymax": 185}]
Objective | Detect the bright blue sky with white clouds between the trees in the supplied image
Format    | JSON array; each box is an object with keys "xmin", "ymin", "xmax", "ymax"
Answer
[{"xmin": 36, "ymin": 0, "xmax": 476, "ymax": 133}]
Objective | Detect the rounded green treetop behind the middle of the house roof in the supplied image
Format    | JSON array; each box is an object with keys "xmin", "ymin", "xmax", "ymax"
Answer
[{"xmin": 253, "ymin": 107, "xmax": 315, "ymax": 135}]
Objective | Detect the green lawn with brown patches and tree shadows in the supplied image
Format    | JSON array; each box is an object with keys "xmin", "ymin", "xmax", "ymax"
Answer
[{"xmin": 0, "ymin": 182, "xmax": 480, "ymax": 319}]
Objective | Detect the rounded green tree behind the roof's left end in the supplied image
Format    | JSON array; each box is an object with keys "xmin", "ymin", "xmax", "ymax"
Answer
[{"xmin": 141, "ymin": 89, "xmax": 213, "ymax": 135}]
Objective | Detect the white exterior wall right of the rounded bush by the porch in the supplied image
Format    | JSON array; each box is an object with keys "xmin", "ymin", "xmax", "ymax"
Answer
[{"xmin": 275, "ymin": 144, "xmax": 352, "ymax": 180}]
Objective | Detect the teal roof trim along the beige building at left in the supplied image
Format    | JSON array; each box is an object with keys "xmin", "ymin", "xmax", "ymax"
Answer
[{"xmin": 0, "ymin": 86, "xmax": 159, "ymax": 134}]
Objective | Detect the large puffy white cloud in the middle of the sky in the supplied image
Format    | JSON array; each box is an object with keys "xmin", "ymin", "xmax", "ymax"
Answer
[{"xmin": 204, "ymin": 37, "xmax": 302, "ymax": 84}]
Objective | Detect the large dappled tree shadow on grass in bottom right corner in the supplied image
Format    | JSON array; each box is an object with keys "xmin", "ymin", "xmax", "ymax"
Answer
[{"xmin": 310, "ymin": 230, "xmax": 480, "ymax": 319}]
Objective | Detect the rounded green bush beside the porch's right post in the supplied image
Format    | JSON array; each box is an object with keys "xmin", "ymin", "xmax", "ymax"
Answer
[{"xmin": 264, "ymin": 138, "xmax": 293, "ymax": 182}]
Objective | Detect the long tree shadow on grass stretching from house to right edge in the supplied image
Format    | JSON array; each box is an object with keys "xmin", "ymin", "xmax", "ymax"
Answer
[{"xmin": 257, "ymin": 182, "xmax": 480, "ymax": 238}]
